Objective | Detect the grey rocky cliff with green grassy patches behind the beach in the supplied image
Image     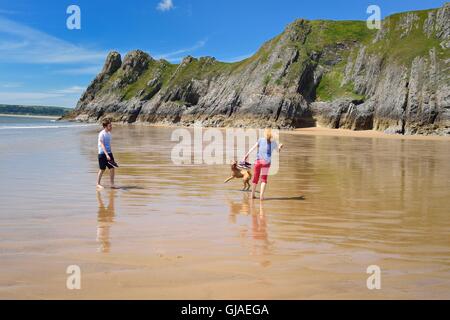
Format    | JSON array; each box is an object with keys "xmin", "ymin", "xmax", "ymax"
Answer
[{"xmin": 67, "ymin": 3, "xmax": 450, "ymax": 135}]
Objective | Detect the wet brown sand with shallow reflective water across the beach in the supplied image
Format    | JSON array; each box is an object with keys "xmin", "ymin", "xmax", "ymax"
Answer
[{"xmin": 0, "ymin": 122, "xmax": 450, "ymax": 299}]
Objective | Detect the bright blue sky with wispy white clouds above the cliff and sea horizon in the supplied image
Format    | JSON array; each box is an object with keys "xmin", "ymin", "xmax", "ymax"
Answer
[{"xmin": 0, "ymin": 0, "xmax": 446, "ymax": 107}]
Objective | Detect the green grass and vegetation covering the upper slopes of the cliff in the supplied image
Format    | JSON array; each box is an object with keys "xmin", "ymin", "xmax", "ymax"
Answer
[{"xmin": 83, "ymin": 4, "xmax": 449, "ymax": 101}]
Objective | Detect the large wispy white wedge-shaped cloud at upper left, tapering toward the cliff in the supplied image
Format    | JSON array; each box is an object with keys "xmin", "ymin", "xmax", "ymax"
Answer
[{"xmin": 0, "ymin": 17, "xmax": 106, "ymax": 64}]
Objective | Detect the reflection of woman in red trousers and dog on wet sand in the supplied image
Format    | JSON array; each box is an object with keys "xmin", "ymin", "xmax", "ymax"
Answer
[{"xmin": 228, "ymin": 194, "xmax": 271, "ymax": 260}]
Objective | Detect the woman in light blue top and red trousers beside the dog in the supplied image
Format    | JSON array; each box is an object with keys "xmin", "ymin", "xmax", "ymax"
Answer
[{"xmin": 244, "ymin": 128, "xmax": 283, "ymax": 201}]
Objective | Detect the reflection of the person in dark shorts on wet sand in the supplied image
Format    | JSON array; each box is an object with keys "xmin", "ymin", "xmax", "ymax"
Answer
[{"xmin": 97, "ymin": 190, "xmax": 116, "ymax": 253}]
